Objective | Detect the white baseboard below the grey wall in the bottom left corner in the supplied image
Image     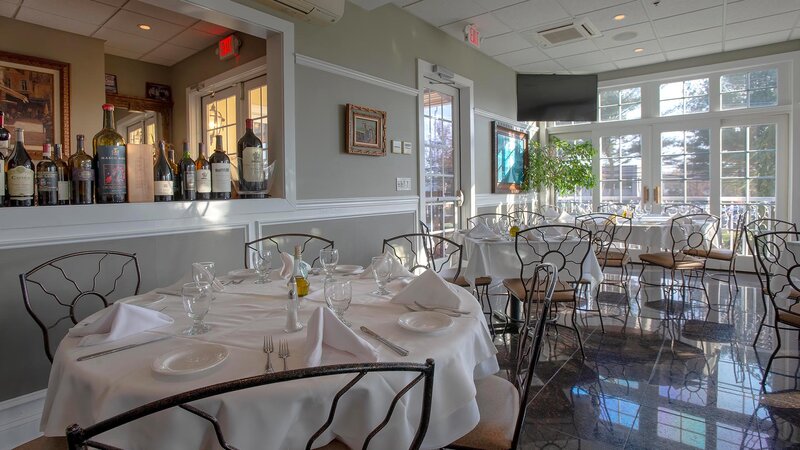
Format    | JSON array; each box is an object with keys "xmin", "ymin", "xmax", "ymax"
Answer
[{"xmin": 0, "ymin": 389, "xmax": 47, "ymax": 450}]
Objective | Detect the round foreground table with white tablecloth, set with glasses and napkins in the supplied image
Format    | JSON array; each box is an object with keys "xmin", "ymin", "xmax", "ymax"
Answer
[{"xmin": 41, "ymin": 250, "xmax": 499, "ymax": 449}]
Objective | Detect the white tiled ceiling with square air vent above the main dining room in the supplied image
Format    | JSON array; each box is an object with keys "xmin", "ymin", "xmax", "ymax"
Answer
[{"xmin": 351, "ymin": 0, "xmax": 800, "ymax": 74}]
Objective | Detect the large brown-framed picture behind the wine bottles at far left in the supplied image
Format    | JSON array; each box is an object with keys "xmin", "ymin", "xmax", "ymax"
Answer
[{"xmin": 0, "ymin": 52, "xmax": 70, "ymax": 160}]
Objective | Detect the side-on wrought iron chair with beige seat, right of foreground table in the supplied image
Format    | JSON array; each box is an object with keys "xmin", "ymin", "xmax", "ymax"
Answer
[{"xmin": 447, "ymin": 263, "xmax": 558, "ymax": 449}]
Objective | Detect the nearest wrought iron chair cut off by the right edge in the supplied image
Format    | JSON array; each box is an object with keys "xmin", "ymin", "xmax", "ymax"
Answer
[{"xmin": 754, "ymin": 231, "xmax": 800, "ymax": 386}]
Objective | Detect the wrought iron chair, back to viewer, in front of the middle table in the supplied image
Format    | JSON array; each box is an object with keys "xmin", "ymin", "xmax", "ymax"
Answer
[{"xmin": 503, "ymin": 225, "xmax": 592, "ymax": 358}]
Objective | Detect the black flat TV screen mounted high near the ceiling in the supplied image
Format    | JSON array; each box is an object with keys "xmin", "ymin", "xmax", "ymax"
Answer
[{"xmin": 517, "ymin": 74, "xmax": 597, "ymax": 122}]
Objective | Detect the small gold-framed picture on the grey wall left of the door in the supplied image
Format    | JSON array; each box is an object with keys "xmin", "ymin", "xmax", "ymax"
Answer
[{"xmin": 346, "ymin": 103, "xmax": 386, "ymax": 156}]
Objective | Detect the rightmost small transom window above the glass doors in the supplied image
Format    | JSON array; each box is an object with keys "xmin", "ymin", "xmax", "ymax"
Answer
[{"xmin": 719, "ymin": 69, "xmax": 778, "ymax": 109}]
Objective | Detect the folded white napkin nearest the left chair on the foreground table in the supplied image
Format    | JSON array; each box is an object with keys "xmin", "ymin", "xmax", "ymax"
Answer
[{"xmin": 67, "ymin": 302, "xmax": 174, "ymax": 347}]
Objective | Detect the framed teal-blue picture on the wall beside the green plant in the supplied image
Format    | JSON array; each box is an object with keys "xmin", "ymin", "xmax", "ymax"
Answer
[{"xmin": 492, "ymin": 121, "xmax": 529, "ymax": 193}]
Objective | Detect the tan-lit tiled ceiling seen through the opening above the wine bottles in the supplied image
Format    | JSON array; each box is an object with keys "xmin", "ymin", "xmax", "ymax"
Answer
[{"xmin": 0, "ymin": 0, "xmax": 231, "ymax": 66}]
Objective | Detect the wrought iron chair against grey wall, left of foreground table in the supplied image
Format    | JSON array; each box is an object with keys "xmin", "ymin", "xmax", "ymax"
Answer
[{"xmin": 19, "ymin": 250, "xmax": 141, "ymax": 362}]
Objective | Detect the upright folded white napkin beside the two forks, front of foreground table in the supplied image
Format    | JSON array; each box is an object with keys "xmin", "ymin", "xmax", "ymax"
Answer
[{"xmin": 306, "ymin": 306, "xmax": 378, "ymax": 367}]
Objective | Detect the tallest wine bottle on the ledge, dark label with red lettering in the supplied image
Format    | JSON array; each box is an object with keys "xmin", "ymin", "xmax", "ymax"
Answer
[{"xmin": 92, "ymin": 104, "xmax": 128, "ymax": 203}]
